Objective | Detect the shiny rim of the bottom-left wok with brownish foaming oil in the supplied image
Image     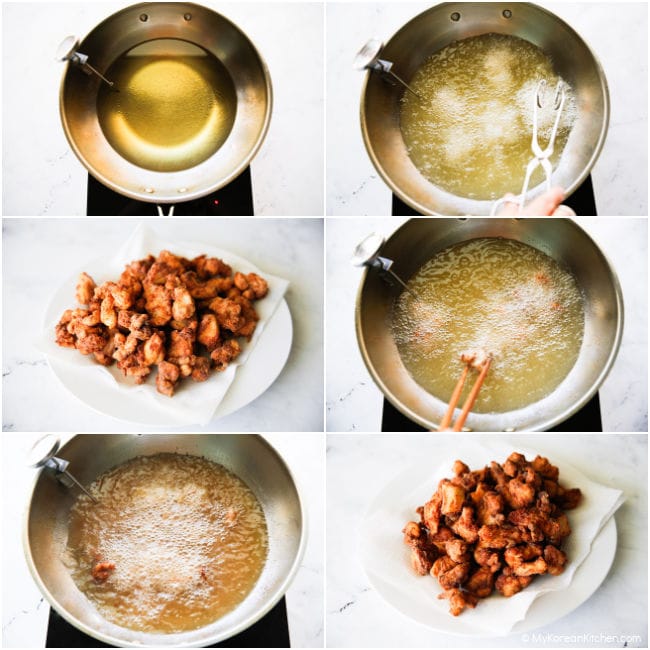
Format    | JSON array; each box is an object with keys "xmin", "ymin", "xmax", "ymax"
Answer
[{"xmin": 22, "ymin": 433, "xmax": 309, "ymax": 648}]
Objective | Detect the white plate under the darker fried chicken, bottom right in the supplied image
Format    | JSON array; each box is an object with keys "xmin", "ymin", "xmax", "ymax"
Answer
[{"xmin": 360, "ymin": 441, "xmax": 617, "ymax": 637}]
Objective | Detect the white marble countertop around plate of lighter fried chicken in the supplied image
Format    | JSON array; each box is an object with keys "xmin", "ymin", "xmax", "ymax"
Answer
[{"xmin": 2, "ymin": 218, "xmax": 323, "ymax": 432}]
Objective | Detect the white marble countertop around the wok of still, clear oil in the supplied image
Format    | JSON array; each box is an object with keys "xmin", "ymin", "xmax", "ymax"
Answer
[{"xmin": 2, "ymin": 2, "xmax": 324, "ymax": 216}]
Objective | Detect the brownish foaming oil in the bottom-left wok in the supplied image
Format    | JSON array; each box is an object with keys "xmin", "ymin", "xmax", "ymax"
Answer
[{"xmin": 66, "ymin": 454, "xmax": 268, "ymax": 633}]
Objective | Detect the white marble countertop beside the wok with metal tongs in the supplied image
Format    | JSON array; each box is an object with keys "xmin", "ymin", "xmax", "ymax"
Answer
[{"xmin": 326, "ymin": 2, "xmax": 648, "ymax": 216}]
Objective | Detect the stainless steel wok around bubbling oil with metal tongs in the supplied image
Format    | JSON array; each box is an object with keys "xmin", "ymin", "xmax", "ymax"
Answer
[{"xmin": 361, "ymin": 2, "xmax": 609, "ymax": 215}]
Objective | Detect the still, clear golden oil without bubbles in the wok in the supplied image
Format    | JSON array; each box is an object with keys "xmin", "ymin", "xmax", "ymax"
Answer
[{"xmin": 97, "ymin": 38, "xmax": 237, "ymax": 172}]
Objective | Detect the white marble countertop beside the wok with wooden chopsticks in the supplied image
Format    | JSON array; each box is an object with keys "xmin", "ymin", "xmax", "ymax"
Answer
[{"xmin": 326, "ymin": 217, "xmax": 648, "ymax": 431}]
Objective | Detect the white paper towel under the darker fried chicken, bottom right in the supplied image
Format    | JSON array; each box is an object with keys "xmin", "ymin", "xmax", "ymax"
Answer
[{"xmin": 359, "ymin": 440, "xmax": 623, "ymax": 635}]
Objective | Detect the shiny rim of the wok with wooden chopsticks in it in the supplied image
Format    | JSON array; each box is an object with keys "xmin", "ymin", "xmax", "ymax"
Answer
[{"xmin": 354, "ymin": 217, "xmax": 625, "ymax": 433}]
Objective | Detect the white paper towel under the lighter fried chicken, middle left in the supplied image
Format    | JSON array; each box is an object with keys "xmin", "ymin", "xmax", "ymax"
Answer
[{"xmin": 36, "ymin": 224, "xmax": 289, "ymax": 425}]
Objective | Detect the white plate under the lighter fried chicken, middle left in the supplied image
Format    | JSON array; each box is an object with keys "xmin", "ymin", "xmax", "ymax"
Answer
[{"xmin": 45, "ymin": 243, "xmax": 293, "ymax": 427}]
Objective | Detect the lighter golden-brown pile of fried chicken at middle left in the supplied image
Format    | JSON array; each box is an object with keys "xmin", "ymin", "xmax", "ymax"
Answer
[{"xmin": 56, "ymin": 251, "xmax": 268, "ymax": 397}]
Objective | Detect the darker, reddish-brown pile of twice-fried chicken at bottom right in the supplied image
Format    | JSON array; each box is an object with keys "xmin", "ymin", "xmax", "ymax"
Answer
[{"xmin": 402, "ymin": 452, "xmax": 582, "ymax": 616}]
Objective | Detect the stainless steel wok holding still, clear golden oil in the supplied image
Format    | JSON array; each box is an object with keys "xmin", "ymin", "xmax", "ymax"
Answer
[{"xmin": 59, "ymin": 2, "xmax": 272, "ymax": 203}]
